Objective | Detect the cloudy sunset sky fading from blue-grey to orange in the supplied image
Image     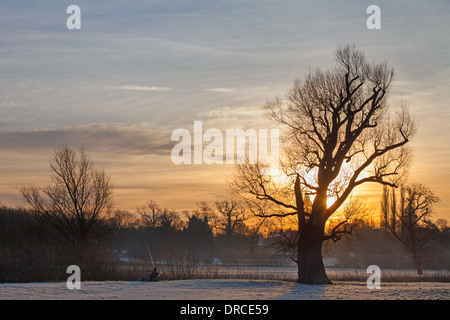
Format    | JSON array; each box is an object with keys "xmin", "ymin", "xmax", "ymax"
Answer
[{"xmin": 0, "ymin": 0, "xmax": 450, "ymax": 220}]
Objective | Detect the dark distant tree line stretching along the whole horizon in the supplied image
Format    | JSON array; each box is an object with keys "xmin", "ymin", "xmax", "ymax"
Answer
[{"xmin": 0, "ymin": 200, "xmax": 450, "ymax": 282}]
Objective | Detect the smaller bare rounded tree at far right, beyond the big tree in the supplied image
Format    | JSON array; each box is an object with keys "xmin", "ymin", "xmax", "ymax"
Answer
[{"xmin": 383, "ymin": 184, "xmax": 439, "ymax": 275}]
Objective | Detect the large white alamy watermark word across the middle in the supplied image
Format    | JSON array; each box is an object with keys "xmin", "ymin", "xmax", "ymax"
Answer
[{"xmin": 171, "ymin": 121, "xmax": 280, "ymax": 169}]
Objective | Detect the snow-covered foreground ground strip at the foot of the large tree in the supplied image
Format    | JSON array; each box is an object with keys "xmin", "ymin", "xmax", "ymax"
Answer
[{"xmin": 0, "ymin": 279, "xmax": 450, "ymax": 300}]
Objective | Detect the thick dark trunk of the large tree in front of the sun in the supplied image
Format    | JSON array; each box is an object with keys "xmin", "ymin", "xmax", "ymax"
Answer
[{"xmin": 297, "ymin": 219, "xmax": 332, "ymax": 284}]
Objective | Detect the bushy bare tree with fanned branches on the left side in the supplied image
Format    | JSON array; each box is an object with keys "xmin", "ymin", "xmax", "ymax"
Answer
[{"xmin": 20, "ymin": 146, "xmax": 113, "ymax": 248}]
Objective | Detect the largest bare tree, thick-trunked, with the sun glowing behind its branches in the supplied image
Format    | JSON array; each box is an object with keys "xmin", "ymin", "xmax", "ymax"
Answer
[{"xmin": 231, "ymin": 46, "xmax": 416, "ymax": 284}]
